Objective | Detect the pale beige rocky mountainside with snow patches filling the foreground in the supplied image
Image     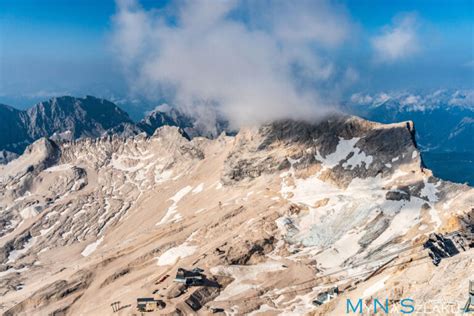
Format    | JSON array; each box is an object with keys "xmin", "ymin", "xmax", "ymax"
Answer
[{"xmin": 0, "ymin": 117, "xmax": 474, "ymax": 315}]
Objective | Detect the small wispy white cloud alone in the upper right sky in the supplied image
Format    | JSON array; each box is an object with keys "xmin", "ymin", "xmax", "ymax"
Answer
[{"xmin": 372, "ymin": 14, "xmax": 419, "ymax": 62}]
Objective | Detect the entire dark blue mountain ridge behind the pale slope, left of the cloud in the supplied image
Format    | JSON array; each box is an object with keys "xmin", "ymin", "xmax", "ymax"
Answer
[{"xmin": 0, "ymin": 96, "xmax": 227, "ymax": 163}]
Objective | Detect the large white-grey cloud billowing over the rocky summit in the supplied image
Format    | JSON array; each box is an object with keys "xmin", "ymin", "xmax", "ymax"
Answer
[{"xmin": 113, "ymin": 0, "xmax": 357, "ymax": 127}]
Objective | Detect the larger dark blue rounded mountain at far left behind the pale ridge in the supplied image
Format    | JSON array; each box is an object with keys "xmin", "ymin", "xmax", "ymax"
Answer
[{"xmin": 0, "ymin": 96, "xmax": 137, "ymax": 154}]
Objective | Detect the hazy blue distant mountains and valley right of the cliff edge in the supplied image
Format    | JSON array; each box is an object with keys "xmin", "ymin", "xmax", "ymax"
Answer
[{"xmin": 345, "ymin": 90, "xmax": 474, "ymax": 185}]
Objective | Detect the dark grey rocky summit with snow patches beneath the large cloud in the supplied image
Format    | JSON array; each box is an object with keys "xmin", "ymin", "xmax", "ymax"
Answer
[{"xmin": 223, "ymin": 115, "xmax": 423, "ymax": 186}]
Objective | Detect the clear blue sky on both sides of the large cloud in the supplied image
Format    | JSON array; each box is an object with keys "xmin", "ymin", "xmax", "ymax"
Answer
[{"xmin": 0, "ymin": 0, "xmax": 474, "ymax": 111}]
